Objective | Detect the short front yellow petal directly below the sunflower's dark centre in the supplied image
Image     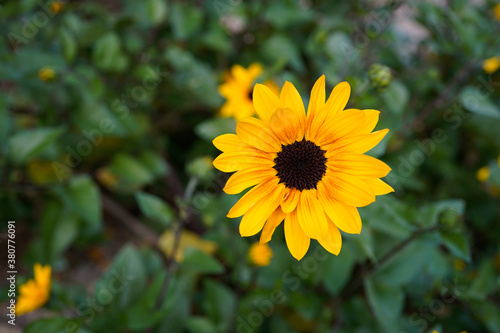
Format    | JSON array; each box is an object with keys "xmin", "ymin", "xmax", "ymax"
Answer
[{"xmin": 297, "ymin": 190, "xmax": 328, "ymax": 239}]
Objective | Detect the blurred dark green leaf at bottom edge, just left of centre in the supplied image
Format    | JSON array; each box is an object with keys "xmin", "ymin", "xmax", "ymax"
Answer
[{"xmin": 204, "ymin": 280, "xmax": 237, "ymax": 332}]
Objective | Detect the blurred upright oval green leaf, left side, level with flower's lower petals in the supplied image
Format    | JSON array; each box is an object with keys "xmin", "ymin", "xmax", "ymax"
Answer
[{"xmin": 68, "ymin": 175, "xmax": 102, "ymax": 231}]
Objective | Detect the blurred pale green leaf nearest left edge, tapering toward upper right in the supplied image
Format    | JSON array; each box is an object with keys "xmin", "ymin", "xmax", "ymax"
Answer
[{"xmin": 8, "ymin": 127, "xmax": 65, "ymax": 164}]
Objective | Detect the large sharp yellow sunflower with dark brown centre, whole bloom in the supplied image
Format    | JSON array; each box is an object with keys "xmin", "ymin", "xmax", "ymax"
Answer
[{"xmin": 213, "ymin": 75, "xmax": 394, "ymax": 260}]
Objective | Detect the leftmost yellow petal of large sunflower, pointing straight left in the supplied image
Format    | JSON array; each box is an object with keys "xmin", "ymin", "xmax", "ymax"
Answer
[{"xmin": 212, "ymin": 148, "xmax": 274, "ymax": 172}]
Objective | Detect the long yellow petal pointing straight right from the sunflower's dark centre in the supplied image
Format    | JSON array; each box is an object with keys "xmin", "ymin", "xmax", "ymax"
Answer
[{"xmin": 326, "ymin": 154, "xmax": 391, "ymax": 178}]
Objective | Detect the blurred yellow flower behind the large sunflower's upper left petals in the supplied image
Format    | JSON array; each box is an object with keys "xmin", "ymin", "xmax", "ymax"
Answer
[{"xmin": 219, "ymin": 63, "xmax": 278, "ymax": 120}]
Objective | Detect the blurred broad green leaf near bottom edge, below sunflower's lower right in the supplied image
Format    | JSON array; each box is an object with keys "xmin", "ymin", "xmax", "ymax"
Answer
[{"xmin": 365, "ymin": 279, "xmax": 405, "ymax": 326}]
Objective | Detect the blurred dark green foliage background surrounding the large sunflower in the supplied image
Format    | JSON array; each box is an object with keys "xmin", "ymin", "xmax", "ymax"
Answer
[{"xmin": 0, "ymin": 0, "xmax": 500, "ymax": 333}]
